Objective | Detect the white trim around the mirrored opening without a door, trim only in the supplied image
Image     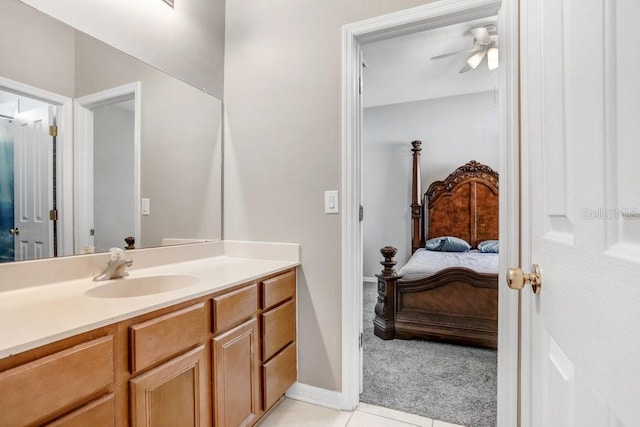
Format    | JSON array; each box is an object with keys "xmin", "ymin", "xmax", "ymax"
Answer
[{"xmin": 73, "ymin": 81, "xmax": 142, "ymax": 251}]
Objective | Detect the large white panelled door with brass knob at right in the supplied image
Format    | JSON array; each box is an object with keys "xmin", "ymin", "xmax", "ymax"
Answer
[{"xmin": 521, "ymin": 0, "xmax": 640, "ymax": 427}]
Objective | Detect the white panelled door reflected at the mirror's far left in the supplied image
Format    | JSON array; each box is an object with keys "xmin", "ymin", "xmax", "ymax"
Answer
[{"xmin": 14, "ymin": 106, "xmax": 53, "ymax": 260}]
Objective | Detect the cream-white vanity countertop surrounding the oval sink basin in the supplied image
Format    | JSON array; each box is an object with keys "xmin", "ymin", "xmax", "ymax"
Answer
[{"xmin": 0, "ymin": 242, "xmax": 300, "ymax": 358}]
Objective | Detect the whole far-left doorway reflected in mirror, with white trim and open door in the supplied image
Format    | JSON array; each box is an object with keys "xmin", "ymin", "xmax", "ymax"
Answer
[{"xmin": 0, "ymin": 78, "xmax": 72, "ymax": 262}]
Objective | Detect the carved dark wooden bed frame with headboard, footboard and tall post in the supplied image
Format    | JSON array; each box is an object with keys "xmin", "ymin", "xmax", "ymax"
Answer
[{"xmin": 373, "ymin": 141, "xmax": 498, "ymax": 348}]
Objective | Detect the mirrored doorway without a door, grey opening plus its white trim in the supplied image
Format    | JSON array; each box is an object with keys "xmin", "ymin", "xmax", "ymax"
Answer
[{"xmin": 75, "ymin": 83, "xmax": 141, "ymax": 253}]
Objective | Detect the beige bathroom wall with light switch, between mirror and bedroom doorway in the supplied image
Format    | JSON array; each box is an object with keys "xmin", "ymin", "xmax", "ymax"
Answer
[{"xmin": 224, "ymin": 0, "xmax": 436, "ymax": 391}]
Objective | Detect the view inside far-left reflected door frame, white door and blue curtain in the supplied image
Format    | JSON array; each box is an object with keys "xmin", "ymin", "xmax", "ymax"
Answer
[{"xmin": 0, "ymin": 91, "xmax": 55, "ymax": 262}]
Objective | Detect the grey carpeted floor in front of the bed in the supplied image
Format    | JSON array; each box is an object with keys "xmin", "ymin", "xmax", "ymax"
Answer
[{"xmin": 360, "ymin": 283, "xmax": 498, "ymax": 427}]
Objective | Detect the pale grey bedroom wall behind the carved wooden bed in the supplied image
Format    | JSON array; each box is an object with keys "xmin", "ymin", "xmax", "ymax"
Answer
[{"xmin": 362, "ymin": 91, "xmax": 499, "ymax": 278}]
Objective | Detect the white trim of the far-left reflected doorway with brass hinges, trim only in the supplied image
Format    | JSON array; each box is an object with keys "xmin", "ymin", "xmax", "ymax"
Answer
[{"xmin": 0, "ymin": 76, "xmax": 73, "ymax": 256}]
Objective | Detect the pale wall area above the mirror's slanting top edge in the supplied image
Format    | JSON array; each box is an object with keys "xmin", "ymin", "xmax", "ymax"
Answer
[{"xmin": 20, "ymin": 0, "xmax": 225, "ymax": 98}]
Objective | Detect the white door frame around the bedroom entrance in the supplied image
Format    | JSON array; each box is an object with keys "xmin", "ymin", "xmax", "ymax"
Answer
[{"xmin": 341, "ymin": 0, "xmax": 520, "ymax": 427}]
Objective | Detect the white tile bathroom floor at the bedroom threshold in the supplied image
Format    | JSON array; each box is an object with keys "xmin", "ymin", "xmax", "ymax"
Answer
[{"xmin": 260, "ymin": 399, "xmax": 463, "ymax": 427}]
